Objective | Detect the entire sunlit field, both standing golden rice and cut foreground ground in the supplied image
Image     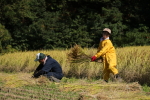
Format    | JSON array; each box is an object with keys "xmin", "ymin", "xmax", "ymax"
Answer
[{"xmin": 0, "ymin": 46, "xmax": 150, "ymax": 100}]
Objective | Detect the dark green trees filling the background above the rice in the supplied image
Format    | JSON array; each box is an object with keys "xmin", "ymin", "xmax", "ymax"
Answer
[{"xmin": 0, "ymin": 0, "xmax": 150, "ymax": 53}]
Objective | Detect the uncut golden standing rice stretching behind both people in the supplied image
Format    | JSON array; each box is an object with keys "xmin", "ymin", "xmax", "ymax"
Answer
[{"xmin": 0, "ymin": 46, "xmax": 150, "ymax": 84}]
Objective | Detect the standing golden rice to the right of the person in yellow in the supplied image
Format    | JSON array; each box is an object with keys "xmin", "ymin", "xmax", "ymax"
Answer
[{"xmin": 117, "ymin": 46, "xmax": 150, "ymax": 84}]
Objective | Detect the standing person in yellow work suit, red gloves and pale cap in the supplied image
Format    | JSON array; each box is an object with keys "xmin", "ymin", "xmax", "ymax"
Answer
[{"xmin": 91, "ymin": 28, "xmax": 118, "ymax": 82}]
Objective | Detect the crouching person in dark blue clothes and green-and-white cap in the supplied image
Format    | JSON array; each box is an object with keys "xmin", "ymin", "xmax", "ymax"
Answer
[{"xmin": 33, "ymin": 53, "xmax": 63, "ymax": 82}]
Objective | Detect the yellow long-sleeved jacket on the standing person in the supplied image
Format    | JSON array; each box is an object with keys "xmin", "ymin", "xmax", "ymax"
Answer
[{"xmin": 95, "ymin": 39, "xmax": 116, "ymax": 66}]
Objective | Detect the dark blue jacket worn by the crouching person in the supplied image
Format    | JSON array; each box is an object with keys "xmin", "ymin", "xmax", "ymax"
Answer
[{"xmin": 33, "ymin": 56, "xmax": 63, "ymax": 79}]
